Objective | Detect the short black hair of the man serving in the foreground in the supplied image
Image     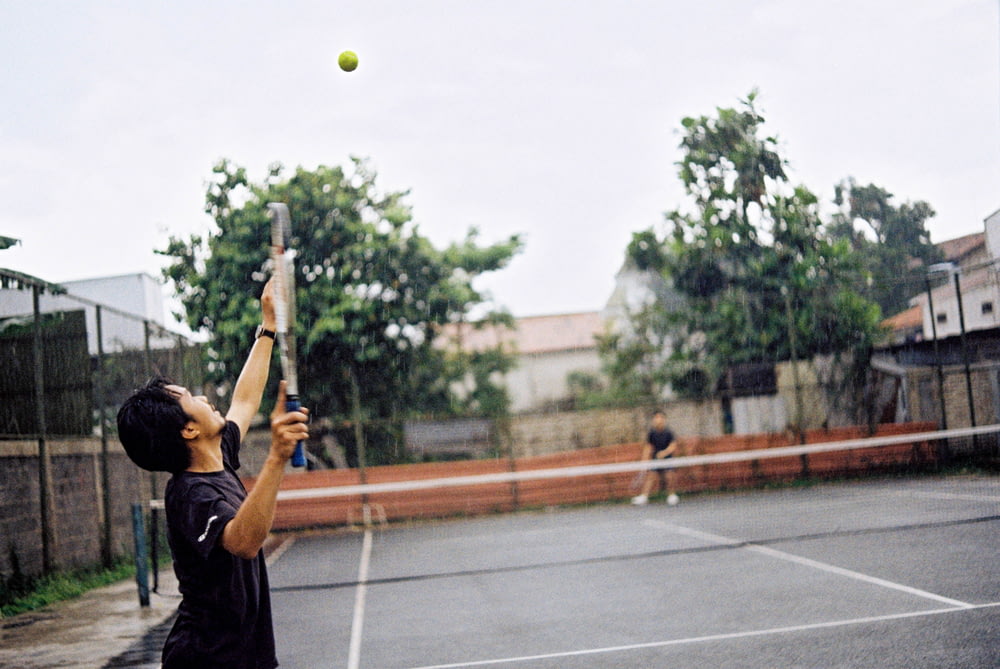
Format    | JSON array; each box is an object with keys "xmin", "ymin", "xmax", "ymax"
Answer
[{"xmin": 118, "ymin": 376, "xmax": 191, "ymax": 474}]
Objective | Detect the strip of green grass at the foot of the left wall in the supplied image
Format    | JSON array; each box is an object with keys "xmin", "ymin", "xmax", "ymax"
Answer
[{"xmin": 0, "ymin": 558, "xmax": 135, "ymax": 618}]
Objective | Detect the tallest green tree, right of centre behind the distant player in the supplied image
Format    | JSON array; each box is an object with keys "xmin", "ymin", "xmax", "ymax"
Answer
[{"xmin": 613, "ymin": 93, "xmax": 879, "ymax": 418}]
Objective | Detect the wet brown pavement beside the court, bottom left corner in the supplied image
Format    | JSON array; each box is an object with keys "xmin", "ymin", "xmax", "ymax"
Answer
[{"xmin": 0, "ymin": 567, "xmax": 180, "ymax": 669}]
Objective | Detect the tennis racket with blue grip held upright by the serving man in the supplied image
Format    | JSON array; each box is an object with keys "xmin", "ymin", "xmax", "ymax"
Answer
[{"xmin": 267, "ymin": 202, "xmax": 306, "ymax": 467}]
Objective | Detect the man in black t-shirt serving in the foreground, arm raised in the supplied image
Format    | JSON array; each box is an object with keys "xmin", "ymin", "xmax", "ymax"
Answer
[{"xmin": 118, "ymin": 282, "xmax": 308, "ymax": 669}]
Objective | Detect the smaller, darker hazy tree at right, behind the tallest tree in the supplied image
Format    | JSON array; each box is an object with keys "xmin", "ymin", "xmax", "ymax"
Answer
[{"xmin": 830, "ymin": 178, "xmax": 942, "ymax": 316}]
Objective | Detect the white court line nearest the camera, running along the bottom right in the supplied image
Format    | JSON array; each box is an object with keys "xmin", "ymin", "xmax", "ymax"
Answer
[{"xmin": 410, "ymin": 602, "xmax": 1000, "ymax": 669}]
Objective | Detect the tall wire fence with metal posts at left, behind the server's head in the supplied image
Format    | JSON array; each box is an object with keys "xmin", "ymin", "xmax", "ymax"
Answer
[{"xmin": 0, "ymin": 270, "xmax": 201, "ymax": 585}]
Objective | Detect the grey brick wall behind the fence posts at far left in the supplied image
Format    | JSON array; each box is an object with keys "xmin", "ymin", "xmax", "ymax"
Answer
[{"xmin": 0, "ymin": 439, "xmax": 154, "ymax": 576}]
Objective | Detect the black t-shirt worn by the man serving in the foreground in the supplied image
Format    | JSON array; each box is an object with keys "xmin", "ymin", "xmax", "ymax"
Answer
[{"xmin": 163, "ymin": 422, "xmax": 278, "ymax": 669}]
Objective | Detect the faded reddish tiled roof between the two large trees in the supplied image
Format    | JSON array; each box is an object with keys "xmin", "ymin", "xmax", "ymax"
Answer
[{"xmin": 444, "ymin": 311, "xmax": 605, "ymax": 355}]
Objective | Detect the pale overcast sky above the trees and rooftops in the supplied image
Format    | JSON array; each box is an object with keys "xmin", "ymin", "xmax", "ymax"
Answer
[{"xmin": 0, "ymin": 0, "xmax": 1000, "ymax": 317}]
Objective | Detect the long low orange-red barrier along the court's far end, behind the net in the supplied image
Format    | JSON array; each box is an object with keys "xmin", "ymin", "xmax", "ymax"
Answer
[{"xmin": 250, "ymin": 425, "xmax": 1000, "ymax": 530}]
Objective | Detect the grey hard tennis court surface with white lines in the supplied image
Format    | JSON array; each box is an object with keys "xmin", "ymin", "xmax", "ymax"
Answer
[{"xmin": 270, "ymin": 475, "xmax": 1000, "ymax": 669}]
